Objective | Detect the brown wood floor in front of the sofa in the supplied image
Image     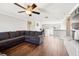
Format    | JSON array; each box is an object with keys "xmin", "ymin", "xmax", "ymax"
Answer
[{"xmin": 2, "ymin": 37, "xmax": 68, "ymax": 56}]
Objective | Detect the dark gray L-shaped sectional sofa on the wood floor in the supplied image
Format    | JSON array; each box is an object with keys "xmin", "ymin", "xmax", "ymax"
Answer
[{"xmin": 0, "ymin": 31, "xmax": 43, "ymax": 51}]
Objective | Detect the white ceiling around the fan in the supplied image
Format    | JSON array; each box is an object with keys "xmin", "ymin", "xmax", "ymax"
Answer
[{"xmin": 0, "ymin": 3, "xmax": 76, "ymax": 21}]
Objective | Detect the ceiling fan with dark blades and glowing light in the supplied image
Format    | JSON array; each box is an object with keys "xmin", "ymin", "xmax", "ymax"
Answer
[{"xmin": 14, "ymin": 3, "xmax": 40, "ymax": 16}]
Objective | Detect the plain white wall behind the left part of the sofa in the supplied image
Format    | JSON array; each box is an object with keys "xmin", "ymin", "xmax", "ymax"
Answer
[{"xmin": 0, "ymin": 14, "xmax": 27, "ymax": 32}]
